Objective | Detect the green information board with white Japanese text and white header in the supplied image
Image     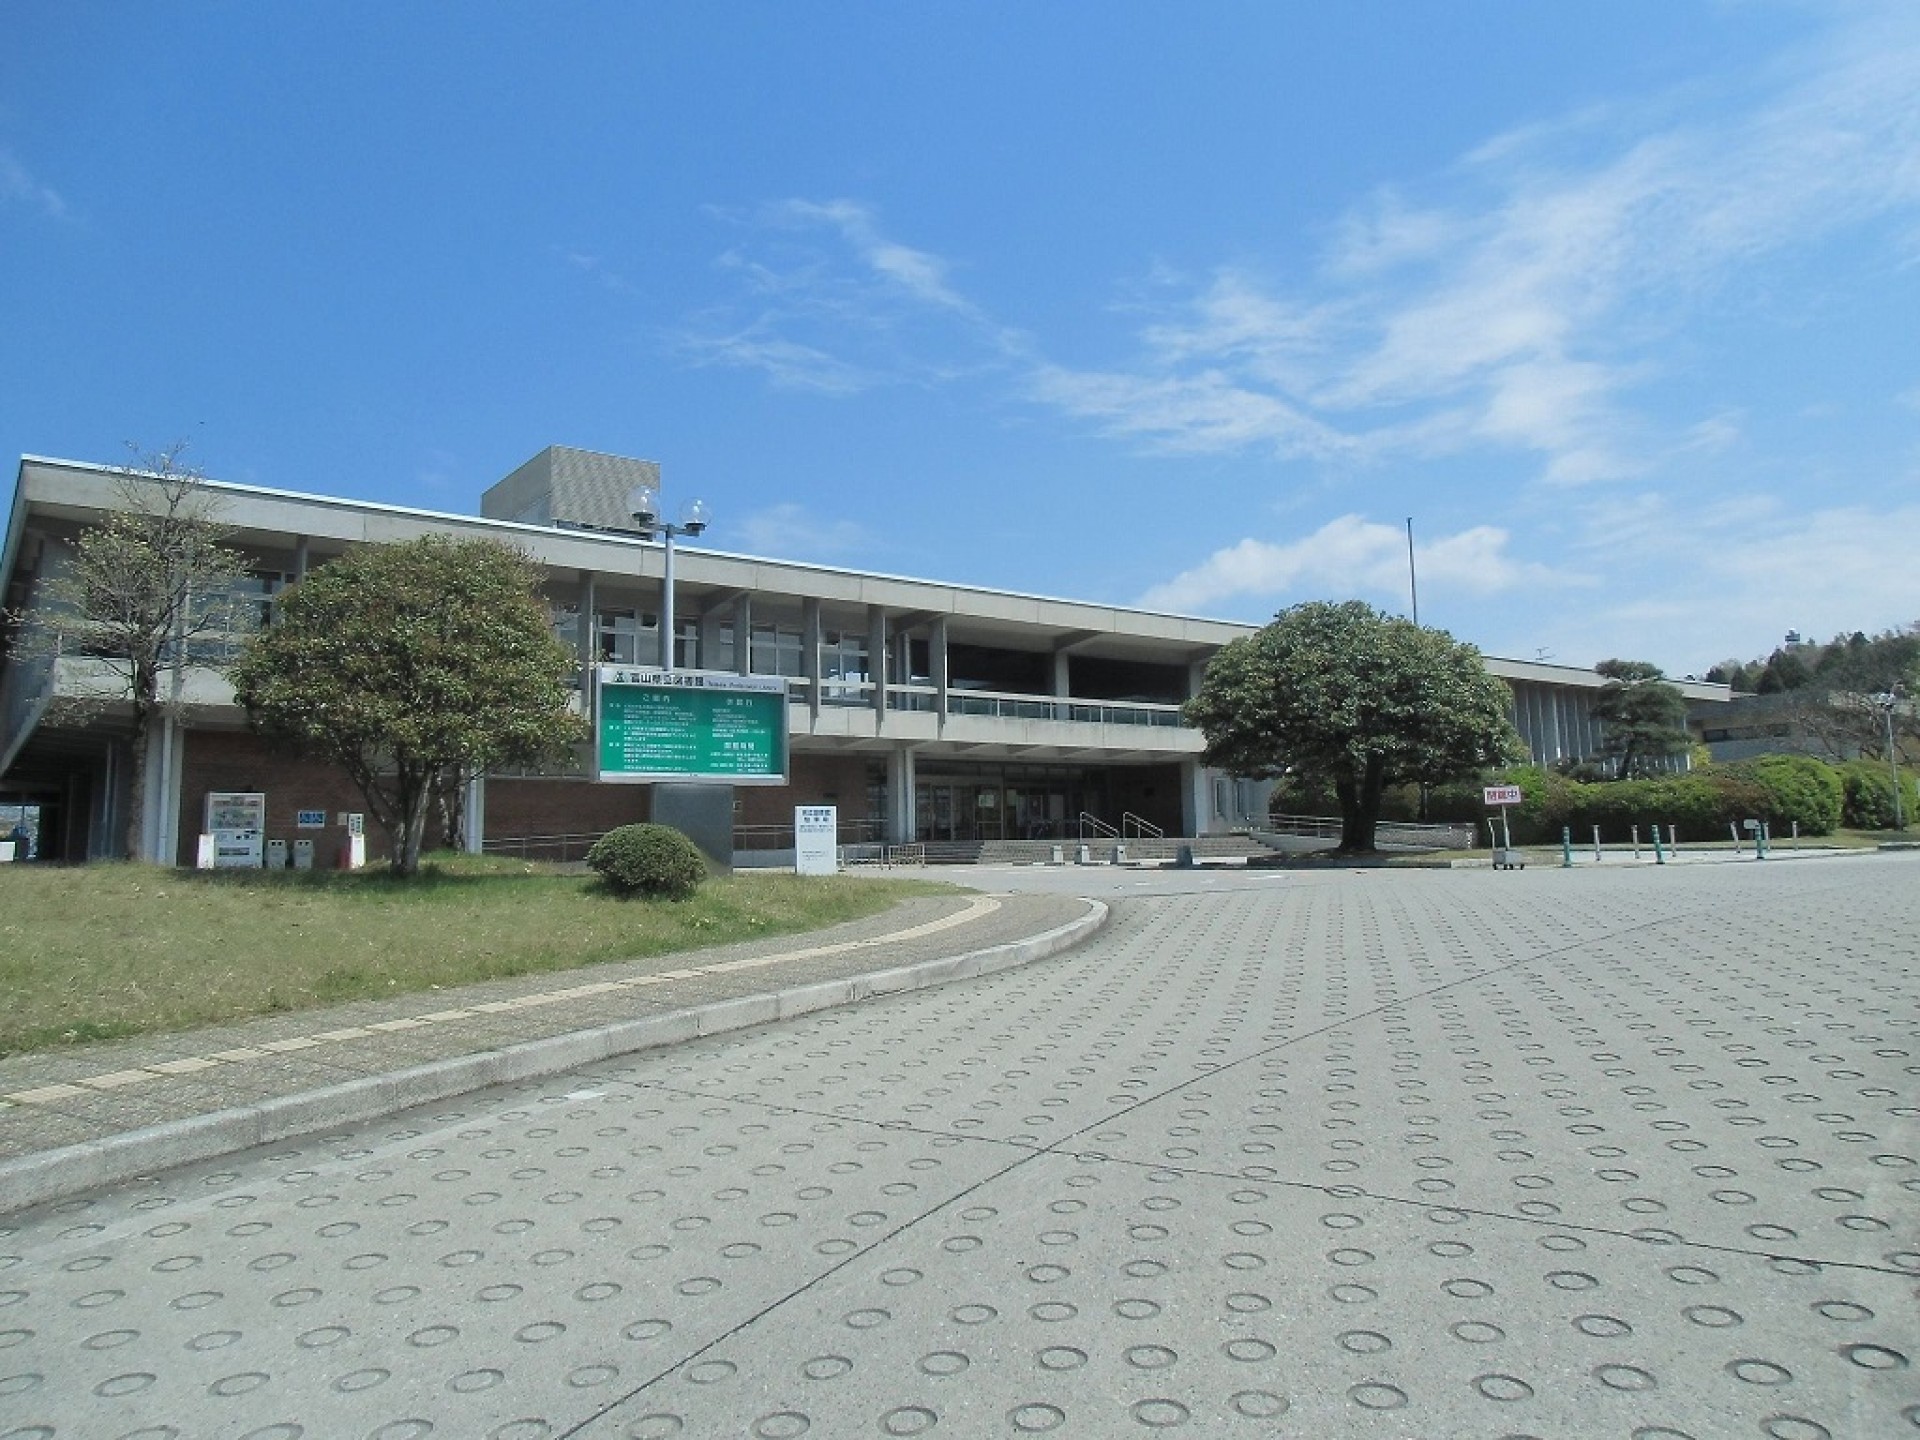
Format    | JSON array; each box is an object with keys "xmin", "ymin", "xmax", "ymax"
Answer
[{"xmin": 593, "ymin": 664, "xmax": 787, "ymax": 785}]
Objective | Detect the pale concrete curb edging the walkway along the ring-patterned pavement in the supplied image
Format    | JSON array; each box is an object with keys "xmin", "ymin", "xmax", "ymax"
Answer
[{"xmin": 0, "ymin": 899, "xmax": 1110, "ymax": 1215}]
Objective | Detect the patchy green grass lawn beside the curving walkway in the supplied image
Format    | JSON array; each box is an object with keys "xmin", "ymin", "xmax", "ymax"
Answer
[{"xmin": 0, "ymin": 856, "xmax": 947, "ymax": 1054}]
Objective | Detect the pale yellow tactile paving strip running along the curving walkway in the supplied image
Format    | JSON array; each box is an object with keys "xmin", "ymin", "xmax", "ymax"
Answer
[{"xmin": 0, "ymin": 895, "xmax": 1000, "ymax": 1108}]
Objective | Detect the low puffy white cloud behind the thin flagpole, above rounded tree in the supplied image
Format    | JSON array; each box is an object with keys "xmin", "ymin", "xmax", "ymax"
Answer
[{"xmin": 1140, "ymin": 515, "xmax": 1559, "ymax": 612}]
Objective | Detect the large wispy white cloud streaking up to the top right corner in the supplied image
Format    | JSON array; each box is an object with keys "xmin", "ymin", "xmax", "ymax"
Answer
[{"xmin": 1033, "ymin": 12, "xmax": 1920, "ymax": 486}]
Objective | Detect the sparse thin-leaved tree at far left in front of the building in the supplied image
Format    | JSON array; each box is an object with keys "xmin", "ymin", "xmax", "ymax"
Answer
[{"xmin": 8, "ymin": 444, "xmax": 255, "ymax": 860}]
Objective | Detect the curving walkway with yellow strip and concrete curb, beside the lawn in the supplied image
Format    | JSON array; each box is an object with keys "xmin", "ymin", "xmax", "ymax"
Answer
[{"xmin": 0, "ymin": 893, "xmax": 1106, "ymax": 1213}]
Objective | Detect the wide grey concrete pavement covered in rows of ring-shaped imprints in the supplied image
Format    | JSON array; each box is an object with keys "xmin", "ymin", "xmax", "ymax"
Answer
[{"xmin": 0, "ymin": 854, "xmax": 1920, "ymax": 1440}]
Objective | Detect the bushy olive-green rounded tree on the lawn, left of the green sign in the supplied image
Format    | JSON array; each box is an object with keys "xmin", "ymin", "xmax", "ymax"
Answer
[{"xmin": 232, "ymin": 536, "xmax": 584, "ymax": 876}]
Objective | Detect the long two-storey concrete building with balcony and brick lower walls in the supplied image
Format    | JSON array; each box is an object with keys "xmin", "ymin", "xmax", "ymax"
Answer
[{"xmin": 0, "ymin": 445, "xmax": 1726, "ymax": 864}]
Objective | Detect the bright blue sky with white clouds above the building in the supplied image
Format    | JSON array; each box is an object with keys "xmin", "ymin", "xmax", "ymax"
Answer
[{"xmin": 0, "ymin": 0, "xmax": 1920, "ymax": 674}]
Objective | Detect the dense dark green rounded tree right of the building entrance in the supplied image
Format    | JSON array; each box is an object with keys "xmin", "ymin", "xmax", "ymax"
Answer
[{"xmin": 1187, "ymin": 601, "xmax": 1521, "ymax": 854}]
